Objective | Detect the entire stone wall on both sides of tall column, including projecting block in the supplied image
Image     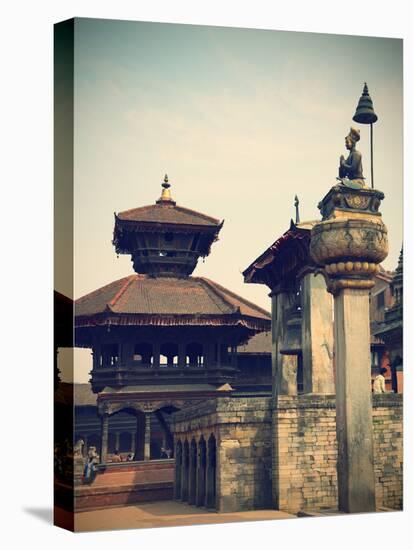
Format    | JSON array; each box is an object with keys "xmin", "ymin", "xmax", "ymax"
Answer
[{"xmin": 173, "ymin": 393, "xmax": 403, "ymax": 513}]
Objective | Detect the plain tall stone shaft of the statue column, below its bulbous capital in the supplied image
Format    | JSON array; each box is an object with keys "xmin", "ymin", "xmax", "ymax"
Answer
[{"xmin": 334, "ymin": 288, "xmax": 375, "ymax": 513}]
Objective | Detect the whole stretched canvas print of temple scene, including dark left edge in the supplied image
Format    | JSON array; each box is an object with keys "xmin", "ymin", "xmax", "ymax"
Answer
[{"xmin": 54, "ymin": 18, "xmax": 403, "ymax": 531}]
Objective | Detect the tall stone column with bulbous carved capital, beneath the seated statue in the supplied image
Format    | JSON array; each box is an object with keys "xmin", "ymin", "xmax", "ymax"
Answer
[{"xmin": 310, "ymin": 185, "xmax": 388, "ymax": 513}]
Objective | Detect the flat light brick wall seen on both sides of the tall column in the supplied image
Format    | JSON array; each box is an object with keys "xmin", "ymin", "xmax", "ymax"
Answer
[{"xmin": 273, "ymin": 394, "xmax": 403, "ymax": 513}]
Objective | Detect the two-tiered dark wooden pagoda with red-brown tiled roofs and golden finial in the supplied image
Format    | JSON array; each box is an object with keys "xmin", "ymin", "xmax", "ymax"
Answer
[{"xmin": 75, "ymin": 176, "xmax": 271, "ymax": 470}]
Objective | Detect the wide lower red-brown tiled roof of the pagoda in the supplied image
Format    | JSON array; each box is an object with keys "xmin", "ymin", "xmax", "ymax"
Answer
[{"xmin": 75, "ymin": 274, "xmax": 271, "ymax": 330}]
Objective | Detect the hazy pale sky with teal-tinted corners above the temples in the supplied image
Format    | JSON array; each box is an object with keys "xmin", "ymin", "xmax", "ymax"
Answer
[{"xmin": 62, "ymin": 19, "xmax": 403, "ymax": 381}]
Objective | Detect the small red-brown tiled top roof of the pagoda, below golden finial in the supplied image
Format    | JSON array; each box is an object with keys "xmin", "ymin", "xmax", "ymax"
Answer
[{"xmin": 117, "ymin": 203, "xmax": 221, "ymax": 227}]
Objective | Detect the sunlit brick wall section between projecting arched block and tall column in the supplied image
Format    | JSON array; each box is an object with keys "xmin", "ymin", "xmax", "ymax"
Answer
[{"xmin": 273, "ymin": 395, "xmax": 337, "ymax": 512}]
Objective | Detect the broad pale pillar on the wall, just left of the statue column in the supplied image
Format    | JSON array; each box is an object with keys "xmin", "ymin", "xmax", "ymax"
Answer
[{"xmin": 301, "ymin": 273, "xmax": 335, "ymax": 394}]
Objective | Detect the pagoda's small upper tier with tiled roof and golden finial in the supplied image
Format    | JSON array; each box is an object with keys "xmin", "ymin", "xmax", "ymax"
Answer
[{"xmin": 113, "ymin": 176, "xmax": 223, "ymax": 277}]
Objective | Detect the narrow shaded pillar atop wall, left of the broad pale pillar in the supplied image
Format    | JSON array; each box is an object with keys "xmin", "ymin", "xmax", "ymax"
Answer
[{"xmin": 271, "ymin": 290, "xmax": 297, "ymax": 397}]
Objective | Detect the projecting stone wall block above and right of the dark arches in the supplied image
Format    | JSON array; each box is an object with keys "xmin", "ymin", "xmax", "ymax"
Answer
[{"xmin": 172, "ymin": 397, "xmax": 271, "ymax": 512}]
